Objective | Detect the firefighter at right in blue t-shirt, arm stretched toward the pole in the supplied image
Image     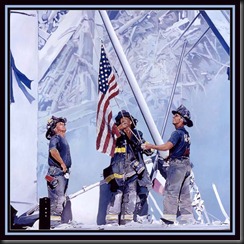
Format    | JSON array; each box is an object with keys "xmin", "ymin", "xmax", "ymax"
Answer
[{"xmin": 142, "ymin": 105, "xmax": 195, "ymax": 224}]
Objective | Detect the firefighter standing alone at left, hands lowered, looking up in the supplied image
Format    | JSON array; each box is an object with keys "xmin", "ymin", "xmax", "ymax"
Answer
[{"xmin": 45, "ymin": 116, "xmax": 72, "ymax": 228}]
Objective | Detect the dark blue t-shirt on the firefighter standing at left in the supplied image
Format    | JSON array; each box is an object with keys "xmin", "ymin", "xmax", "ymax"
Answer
[{"xmin": 48, "ymin": 135, "xmax": 71, "ymax": 168}]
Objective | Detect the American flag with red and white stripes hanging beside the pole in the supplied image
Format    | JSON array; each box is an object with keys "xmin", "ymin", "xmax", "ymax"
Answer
[{"xmin": 96, "ymin": 44, "xmax": 119, "ymax": 156}]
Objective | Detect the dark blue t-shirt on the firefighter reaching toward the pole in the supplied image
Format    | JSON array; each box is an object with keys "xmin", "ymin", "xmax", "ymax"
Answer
[{"xmin": 168, "ymin": 127, "xmax": 191, "ymax": 159}]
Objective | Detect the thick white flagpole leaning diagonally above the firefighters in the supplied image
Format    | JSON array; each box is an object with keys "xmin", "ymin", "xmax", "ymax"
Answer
[{"xmin": 98, "ymin": 10, "xmax": 168, "ymax": 158}]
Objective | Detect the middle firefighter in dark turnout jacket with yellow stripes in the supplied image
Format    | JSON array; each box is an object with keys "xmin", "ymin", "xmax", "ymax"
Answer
[{"xmin": 104, "ymin": 110, "xmax": 153, "ymax": 225}]
